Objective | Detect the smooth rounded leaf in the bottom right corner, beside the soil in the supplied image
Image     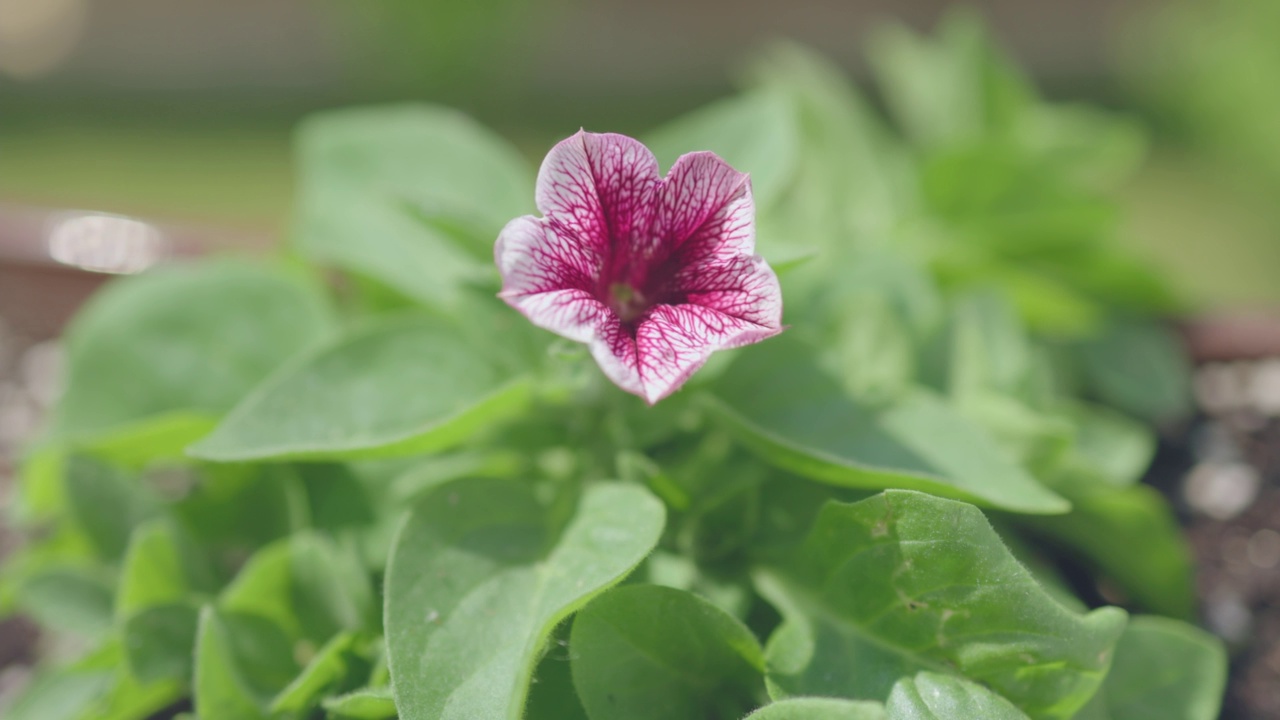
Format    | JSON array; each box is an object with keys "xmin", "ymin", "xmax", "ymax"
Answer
[{"xmin": 1076, "ymin": 616, "xmax": 1228, "ymax": 720}]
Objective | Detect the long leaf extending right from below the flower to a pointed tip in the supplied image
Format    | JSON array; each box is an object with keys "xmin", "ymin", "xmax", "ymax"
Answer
[{"xmin": 713, "ymin": 338, "xmax": 1070, "ymax": 514}]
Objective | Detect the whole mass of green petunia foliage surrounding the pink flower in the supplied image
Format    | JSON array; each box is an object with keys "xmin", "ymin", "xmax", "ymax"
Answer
[{"xmin": 0, "ymin": 11, "xmax": 1225, "ymax": 720}]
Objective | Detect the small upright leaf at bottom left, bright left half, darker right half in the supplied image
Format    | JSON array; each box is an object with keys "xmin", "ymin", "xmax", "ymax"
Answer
[{"xmin": 193, "ymin": 606, "xmax": 298, "ymax": 720}]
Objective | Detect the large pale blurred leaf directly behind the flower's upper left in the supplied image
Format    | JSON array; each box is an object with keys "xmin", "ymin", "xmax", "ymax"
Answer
[{"xmin": 296, "ymin": 105, "xmax": 534, "ymax": 305}]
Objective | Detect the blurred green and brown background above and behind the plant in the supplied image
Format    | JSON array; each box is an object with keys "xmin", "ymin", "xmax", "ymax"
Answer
[{"xmin": 0, "ymin": 0, "xmax": 1280, "ymax": 309}]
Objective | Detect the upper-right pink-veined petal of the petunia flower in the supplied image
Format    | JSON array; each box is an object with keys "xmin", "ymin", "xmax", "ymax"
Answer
[{"xmin": 655, "ymin": 152, "xmax": 755, "ymax": 266}]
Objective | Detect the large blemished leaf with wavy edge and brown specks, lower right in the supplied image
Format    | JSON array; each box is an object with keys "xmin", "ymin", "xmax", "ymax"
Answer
[{"xmin": 756, "ymin": 491, "xmax": 1125, "ymax": 717}]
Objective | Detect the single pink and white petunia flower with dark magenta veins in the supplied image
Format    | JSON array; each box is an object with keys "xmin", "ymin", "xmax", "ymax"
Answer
[{"xmin": 494, "ymin": 132, "xmax": 782, "ymax": 405}]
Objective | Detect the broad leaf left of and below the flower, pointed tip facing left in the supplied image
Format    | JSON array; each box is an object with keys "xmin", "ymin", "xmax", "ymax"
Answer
[{"xmin": 188, "ymin": 318, "xmax": 529, "ymax": 462}]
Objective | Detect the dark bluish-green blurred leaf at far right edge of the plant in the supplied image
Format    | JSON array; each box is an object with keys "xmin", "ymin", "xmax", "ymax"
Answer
[{"xmin": 1080, "ymin": 320, "xmax": 1190, "ymax": 421}]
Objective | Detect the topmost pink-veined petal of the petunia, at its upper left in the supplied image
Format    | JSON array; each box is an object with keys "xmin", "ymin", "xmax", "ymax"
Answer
[{"xmin": 536, "ymin": 131, "xmax": 658, "ymax": 258}]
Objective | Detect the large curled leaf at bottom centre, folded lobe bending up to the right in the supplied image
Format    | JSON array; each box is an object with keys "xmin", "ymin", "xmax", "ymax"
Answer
[{"xmin": 385, "ymin": 479, "xmax": 664, "ymax": 720}]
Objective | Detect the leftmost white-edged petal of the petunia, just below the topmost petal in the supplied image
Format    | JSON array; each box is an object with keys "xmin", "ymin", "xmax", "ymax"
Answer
[{"xmin": 493, "ymin": 215, "xmax": 603, "ymax": 294}]
